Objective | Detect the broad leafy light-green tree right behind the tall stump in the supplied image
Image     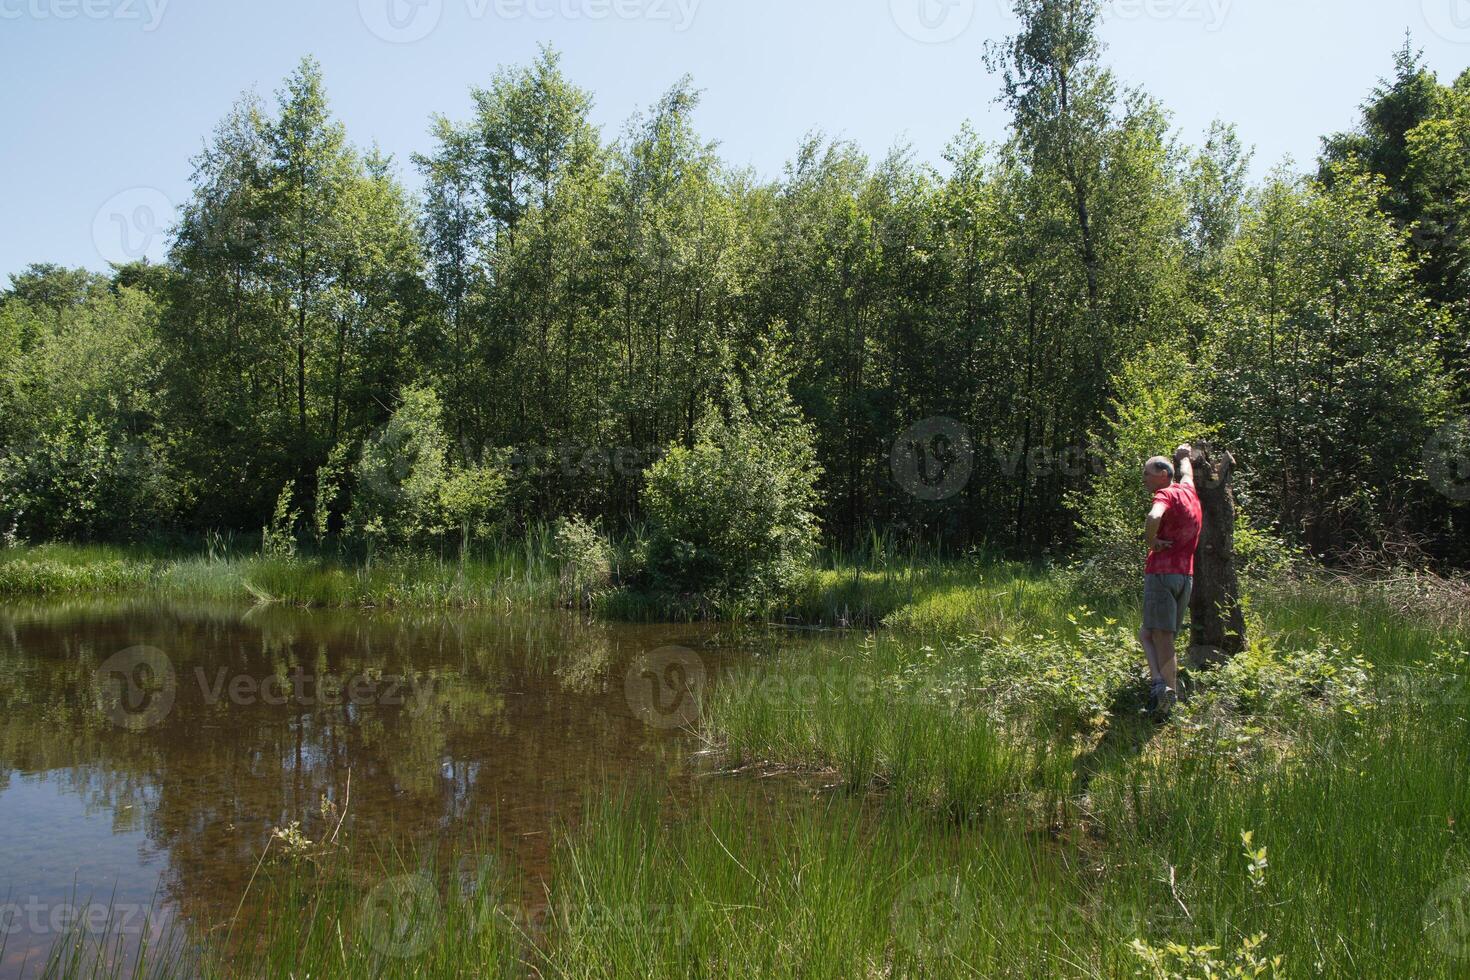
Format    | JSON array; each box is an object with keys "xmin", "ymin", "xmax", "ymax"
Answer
[{"xmin": 1210, "ymin": 167, "xmax": 1449, "ymax": 552}]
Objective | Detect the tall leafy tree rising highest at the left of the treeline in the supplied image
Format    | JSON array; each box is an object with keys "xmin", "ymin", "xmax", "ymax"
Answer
[{"xmin": 165, "ymin": 59, "xmax": 422, "ymax": 526}]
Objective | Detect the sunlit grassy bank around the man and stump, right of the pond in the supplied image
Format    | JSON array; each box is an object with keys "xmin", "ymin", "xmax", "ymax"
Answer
[{"xmin": 704, "ymin": 579, "xmax": 1470, "ymax": 977}]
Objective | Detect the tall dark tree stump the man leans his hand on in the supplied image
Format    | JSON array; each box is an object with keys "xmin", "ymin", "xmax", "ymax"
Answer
[{"xmin": 1188, "ymin": 445, "xmax": 1245, "ymax": 667}]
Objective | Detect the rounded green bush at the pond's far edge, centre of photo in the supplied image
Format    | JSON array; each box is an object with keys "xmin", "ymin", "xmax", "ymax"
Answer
[{"xmin": 642, "ymin": 413, "xmax": 819, "ymax": 605}]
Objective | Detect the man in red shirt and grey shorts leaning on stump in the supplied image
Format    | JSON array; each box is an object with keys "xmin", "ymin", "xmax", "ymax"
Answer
[{"xmin": 1138, "ymin": 445, "xmax": 1204, "ymax": 716}]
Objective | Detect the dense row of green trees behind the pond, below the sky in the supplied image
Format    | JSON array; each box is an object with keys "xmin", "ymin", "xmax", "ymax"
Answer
[{"xmin": 0, "ymin": 0, "xmax": 1470, "ymax": 560}]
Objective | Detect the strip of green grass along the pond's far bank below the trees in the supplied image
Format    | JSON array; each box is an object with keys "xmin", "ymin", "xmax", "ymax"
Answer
[{"xmin": 0, "ymin": 529, "xmax": 1105, "ymax": 636}]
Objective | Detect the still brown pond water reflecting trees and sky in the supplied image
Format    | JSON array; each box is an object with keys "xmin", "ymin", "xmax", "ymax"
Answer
[{"xmin": 0, "ymin": 599, "xmax": 810, "ymax": 977}]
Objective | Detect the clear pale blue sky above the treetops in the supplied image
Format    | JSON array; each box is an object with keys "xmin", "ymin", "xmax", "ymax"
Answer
[{"xmin": 0, "ymin": 0, "xmax": 1470, "ymax": 282}]
